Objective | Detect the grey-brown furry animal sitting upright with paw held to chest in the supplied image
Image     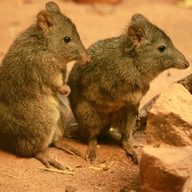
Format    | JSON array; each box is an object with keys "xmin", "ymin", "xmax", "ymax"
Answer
[{"xmin": 0, "ymin": 2, "xmax": 89, "ymax": 169}]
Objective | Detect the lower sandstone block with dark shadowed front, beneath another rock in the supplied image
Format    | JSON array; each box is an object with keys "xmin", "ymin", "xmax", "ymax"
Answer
[{"xmin": 140, "ymin": 145, "xmax": 192, "ymax": 192}]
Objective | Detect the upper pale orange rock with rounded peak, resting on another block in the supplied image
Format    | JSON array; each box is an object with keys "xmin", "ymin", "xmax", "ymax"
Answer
[{"xmin": 146, "ymin": 83, "xmax": 192, "ymax": 146}]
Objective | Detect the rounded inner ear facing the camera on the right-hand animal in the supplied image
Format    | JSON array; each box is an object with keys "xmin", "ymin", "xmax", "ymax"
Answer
[{"xmin": 128, "ymin": 26, "xmax": 145, "ymax": 44}]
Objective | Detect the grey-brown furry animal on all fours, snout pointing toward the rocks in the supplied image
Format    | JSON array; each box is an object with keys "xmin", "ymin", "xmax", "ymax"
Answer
[{"xmin": 68, "ymin": 14, "xmax": 189, "ymax": 163}]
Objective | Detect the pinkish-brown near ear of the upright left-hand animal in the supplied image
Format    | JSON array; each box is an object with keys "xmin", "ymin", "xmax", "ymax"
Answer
[{"xmin": 37, "ymin": 11, "xmax": 53, "ymax": 31}]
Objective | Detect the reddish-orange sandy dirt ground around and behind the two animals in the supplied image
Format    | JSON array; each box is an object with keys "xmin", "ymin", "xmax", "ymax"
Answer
[{"xmin": 0, "ymin": 0, "xmax": 192, "ymax": 192}]
